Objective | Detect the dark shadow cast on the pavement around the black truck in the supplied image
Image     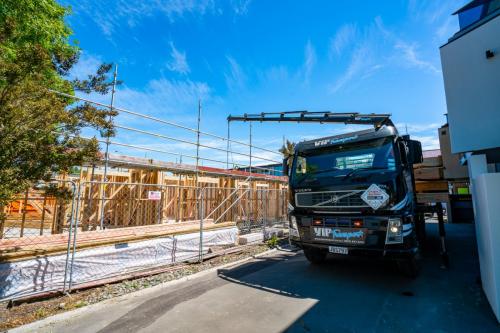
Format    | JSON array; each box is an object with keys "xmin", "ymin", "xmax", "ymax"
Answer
[{"xmin": 218, "ymin": 224, "xmax": 500, "ymax": 332}]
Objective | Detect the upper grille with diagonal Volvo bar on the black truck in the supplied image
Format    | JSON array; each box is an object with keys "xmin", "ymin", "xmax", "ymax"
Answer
[{"xmin": 295, "ymin": 190, "xmax": 369, "ymax": 208}]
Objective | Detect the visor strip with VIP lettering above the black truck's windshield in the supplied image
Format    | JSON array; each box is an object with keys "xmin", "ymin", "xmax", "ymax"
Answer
[{"xmin": 295, "ymin": 125, "xmax": 398, "ymax": 152}]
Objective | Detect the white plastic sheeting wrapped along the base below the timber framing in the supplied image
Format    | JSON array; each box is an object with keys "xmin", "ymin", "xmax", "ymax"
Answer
[{"xmin": 0, "ymin": 228, "xmax": 238, "ymax": 299}]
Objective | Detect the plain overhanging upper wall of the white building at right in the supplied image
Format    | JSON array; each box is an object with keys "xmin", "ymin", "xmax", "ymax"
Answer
[{"xmin": 440, "ymin": 16, "xmax": 500, "ymax": 153}]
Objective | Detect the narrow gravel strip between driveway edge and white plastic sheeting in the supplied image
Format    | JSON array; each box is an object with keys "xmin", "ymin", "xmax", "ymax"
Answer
[{"xmin": 0, "ymin": 244, "xmax": 278, "ymax": 331}]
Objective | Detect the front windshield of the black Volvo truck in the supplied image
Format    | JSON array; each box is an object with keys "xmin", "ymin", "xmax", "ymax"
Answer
[{"xmin": 292, "ymin": 137, "xmax": 396, "ymax": 185}]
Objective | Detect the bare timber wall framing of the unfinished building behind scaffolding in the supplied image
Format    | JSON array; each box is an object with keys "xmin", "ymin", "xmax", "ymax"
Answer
[{"xmin": 0, "ymin": 156, "xmax": 288, "ymax": 238}]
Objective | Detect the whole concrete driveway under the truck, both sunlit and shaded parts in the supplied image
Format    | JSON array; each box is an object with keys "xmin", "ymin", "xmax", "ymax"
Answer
[{"xmin": 12, "ymin": 225, "xmax": 500, "ymax": 333}]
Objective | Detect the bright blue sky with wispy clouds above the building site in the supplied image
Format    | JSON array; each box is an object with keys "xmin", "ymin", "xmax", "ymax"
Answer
[{"xmin": 62, "ymin": 0, "xmax": 467, "ymax": 166}]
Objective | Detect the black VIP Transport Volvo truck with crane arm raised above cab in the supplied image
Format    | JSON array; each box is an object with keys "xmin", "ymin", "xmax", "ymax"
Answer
[{"xmin": 231, "ymin": 112, "xmax": 425, "ymax": 276}]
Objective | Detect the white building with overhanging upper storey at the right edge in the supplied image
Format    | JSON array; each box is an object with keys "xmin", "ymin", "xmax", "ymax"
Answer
[{"xmin": 440, "ymin": 0, "xmax": 500, "ymax": 321}]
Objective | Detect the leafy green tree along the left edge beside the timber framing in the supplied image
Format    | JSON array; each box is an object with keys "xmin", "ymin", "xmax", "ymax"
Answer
[{"xmin": 0, "ymin": 0, "xmax": 115, "ymax": 210}]
